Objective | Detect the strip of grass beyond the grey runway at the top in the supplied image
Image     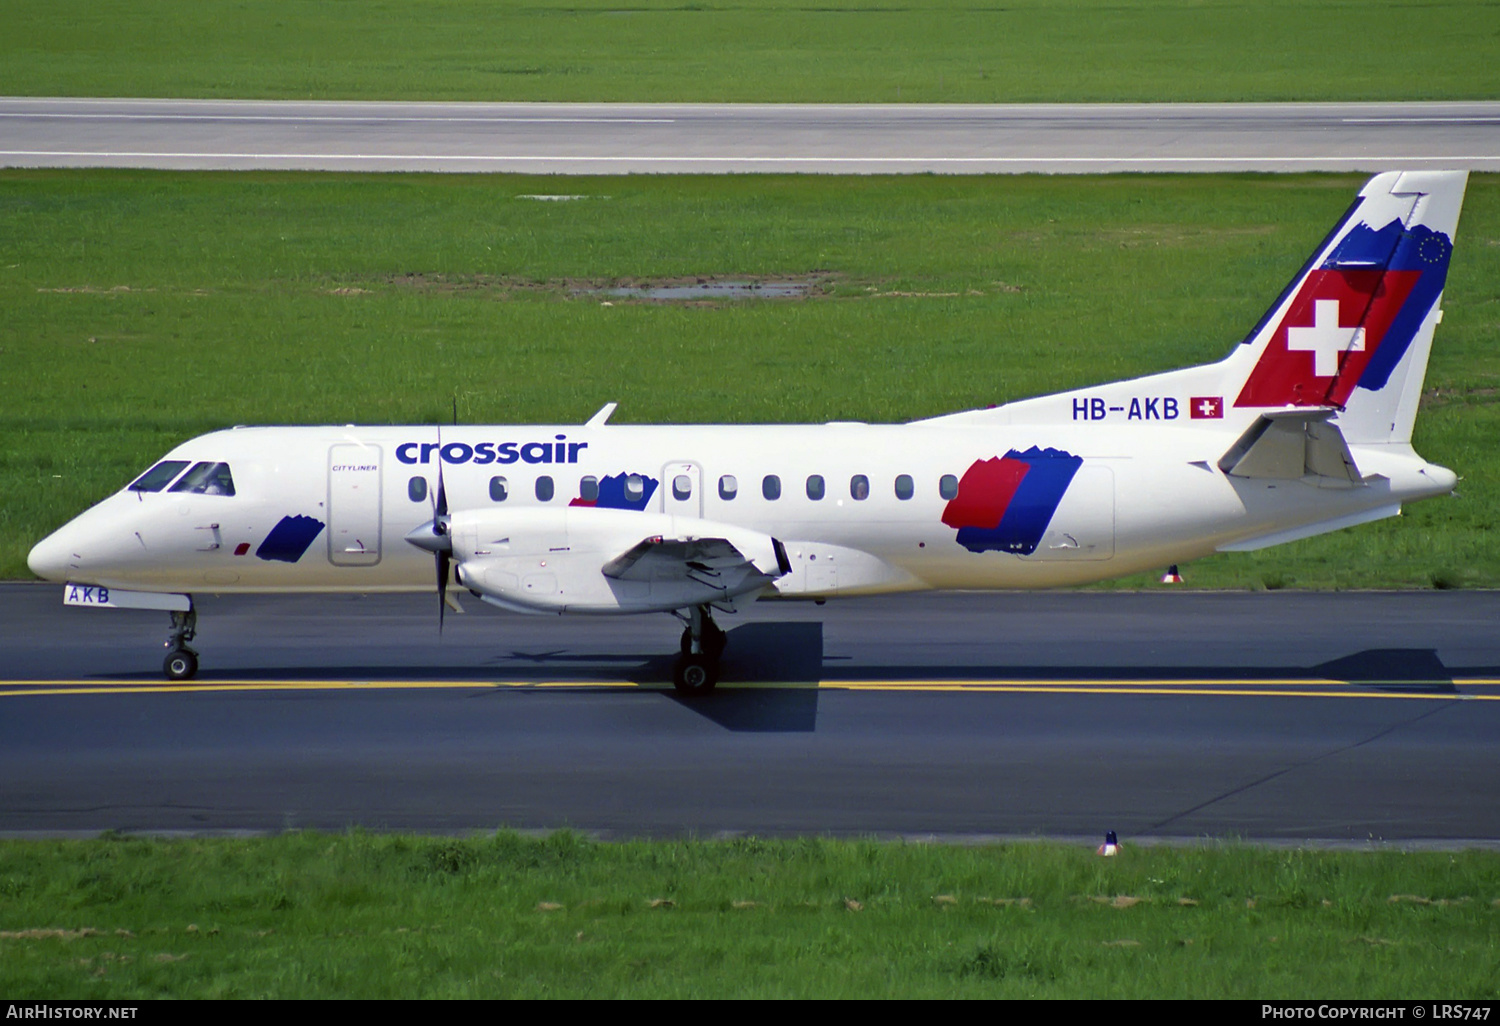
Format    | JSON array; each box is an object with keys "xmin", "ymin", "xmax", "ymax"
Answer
[{"xmin": 0, "ymin": 0, "xmax": 1500, "ymax": 104}]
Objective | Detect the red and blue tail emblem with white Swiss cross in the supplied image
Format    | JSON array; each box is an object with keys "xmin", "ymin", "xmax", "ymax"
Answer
[{"xmin": 1235, "ymin": 219, "xmax": 1454, "ymax": 407}]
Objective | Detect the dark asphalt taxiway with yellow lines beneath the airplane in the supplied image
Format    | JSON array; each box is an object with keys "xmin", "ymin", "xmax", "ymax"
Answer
[{"xmin": 0, "ymin": 585, "xmax": 1500, "ymax": 846}]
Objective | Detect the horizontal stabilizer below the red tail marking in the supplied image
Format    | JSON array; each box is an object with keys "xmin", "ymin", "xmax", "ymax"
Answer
[{"xmin": 1218, "ymin": 407, "xmax": 1364, "ymax": 486}]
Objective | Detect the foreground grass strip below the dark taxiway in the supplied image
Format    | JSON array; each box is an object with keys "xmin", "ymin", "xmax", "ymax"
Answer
[{"xmin": 0, "ymin": 834, "xmax": 1500, "ymax": 1001}]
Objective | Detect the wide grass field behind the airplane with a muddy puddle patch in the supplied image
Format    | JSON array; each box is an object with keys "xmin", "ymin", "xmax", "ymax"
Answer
[{"xmin": 0, "ymin": 171, "xmax": 1500, "ymax": 588}]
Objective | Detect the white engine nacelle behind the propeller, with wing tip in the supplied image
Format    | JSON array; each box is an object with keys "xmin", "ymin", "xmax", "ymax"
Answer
[{"xmin": 450, "ymin": 506, "xmax": 789, "ymax": 614}]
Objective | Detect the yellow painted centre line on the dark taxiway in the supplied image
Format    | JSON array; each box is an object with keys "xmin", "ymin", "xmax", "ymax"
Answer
[{"xmin": 0, "ymin": 678, "xmax": 1500, "ymax": 702}]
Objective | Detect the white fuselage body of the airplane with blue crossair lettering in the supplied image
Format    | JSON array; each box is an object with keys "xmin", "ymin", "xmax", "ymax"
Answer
[{"xmin": 30, "ymin": 422, "xmax": 1454, "ymax": 600}]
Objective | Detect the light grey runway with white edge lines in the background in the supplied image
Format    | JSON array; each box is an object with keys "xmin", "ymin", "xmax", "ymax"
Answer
[{"xmin": 0, "ymin": 98, "xmax": 1500, "ymax": 174}]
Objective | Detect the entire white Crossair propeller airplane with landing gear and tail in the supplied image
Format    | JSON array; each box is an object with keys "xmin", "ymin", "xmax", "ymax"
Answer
[{"xmin": 29, "ymin": 171, "xmax": 1467, "ymax": 692}]
